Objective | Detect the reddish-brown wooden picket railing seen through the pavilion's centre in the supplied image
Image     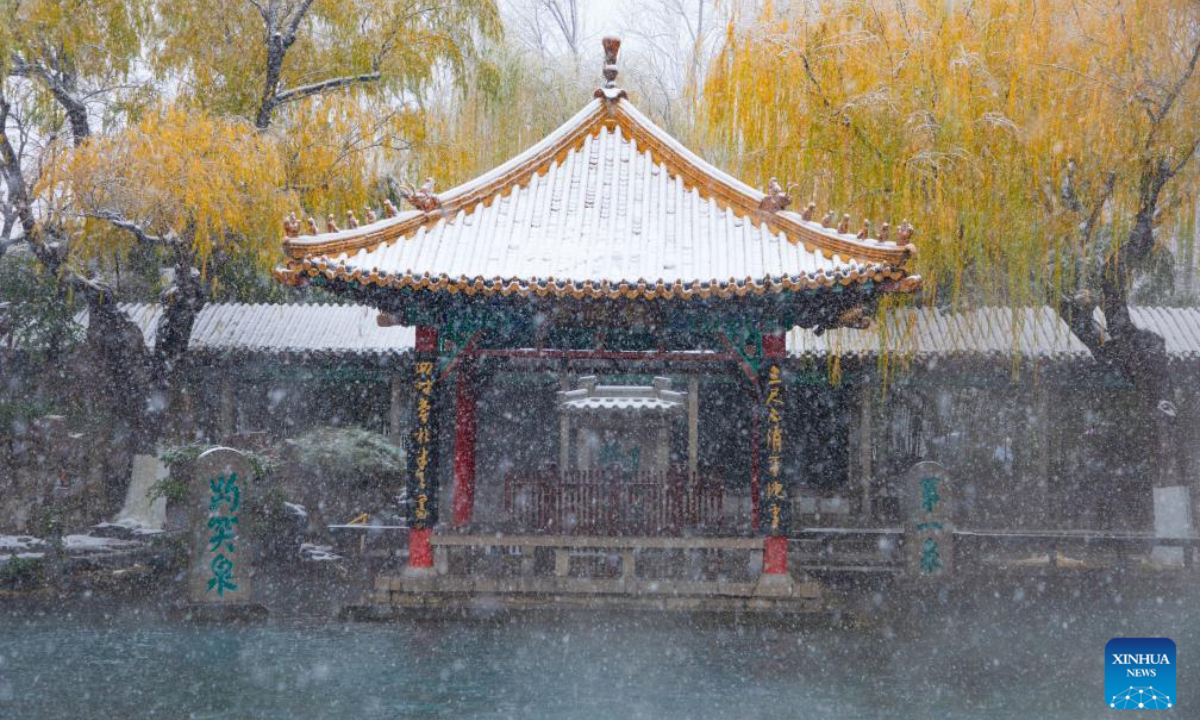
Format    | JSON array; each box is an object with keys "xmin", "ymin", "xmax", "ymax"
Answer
[{"xmin": 504, "ymin": 470, "xmax": 725, "ymax": 535}]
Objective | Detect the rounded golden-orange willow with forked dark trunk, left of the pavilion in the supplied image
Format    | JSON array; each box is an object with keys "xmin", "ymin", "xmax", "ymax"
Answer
[{"xmin": 42, "ymin": 108, "xmax": 289, "ymax": 446}]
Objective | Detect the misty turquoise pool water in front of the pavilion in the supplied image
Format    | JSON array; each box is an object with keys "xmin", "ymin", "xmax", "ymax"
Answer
[{"xmin": 0, "ymin": 598, "xmax": 1200, "ymax": 720}]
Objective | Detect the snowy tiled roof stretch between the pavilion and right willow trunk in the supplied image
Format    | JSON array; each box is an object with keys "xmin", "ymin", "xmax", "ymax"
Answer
[{"xmin": 787, "ymin": 307, "xmax": 1092, "ymax": 360}]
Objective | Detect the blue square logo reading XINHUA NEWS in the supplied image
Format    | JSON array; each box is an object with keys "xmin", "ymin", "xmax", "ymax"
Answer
[{"xmin": 1104, "ymin": 637, "xmax": 1177, "ymax": 710}]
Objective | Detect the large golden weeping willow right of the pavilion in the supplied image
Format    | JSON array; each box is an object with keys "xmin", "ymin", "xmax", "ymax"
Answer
[{"xmin": 704, "ymin": 0, "xmax": 1200, "ymax": 484}]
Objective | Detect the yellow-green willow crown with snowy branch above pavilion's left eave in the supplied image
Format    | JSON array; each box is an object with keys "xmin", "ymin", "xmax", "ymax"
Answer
[{"xmin": 154, "ymin": 0, "xmax": 500, "ymax": 212}]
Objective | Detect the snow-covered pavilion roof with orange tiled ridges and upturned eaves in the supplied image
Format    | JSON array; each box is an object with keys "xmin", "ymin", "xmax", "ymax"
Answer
[{"xmin": 276, "ymin": 42, "xmax": 919, "ymax": 299}]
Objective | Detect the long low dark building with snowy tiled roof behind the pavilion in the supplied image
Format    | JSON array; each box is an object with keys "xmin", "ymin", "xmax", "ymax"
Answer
[{"xmin": 58, "ymin": 297, "xmax": 1200, "ymax": 529}]
